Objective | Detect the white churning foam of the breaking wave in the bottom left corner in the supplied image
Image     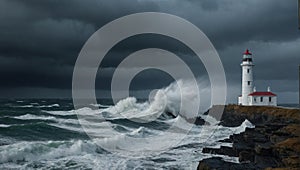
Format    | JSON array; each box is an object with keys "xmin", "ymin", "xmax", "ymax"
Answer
[{"xmin": 0, "ymin": 140, "xmax": 141, "ymax": 169}]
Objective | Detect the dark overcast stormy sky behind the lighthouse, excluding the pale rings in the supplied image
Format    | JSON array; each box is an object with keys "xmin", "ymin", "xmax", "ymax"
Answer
[{"xmin": 0, "ymin": 0, "xmax": 300, "ymax": 103}]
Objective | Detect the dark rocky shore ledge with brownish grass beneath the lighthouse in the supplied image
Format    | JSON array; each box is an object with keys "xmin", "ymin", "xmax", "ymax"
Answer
[{"xmin": 198, "ymin": 105, "xmax": 300, "ymax": 170}]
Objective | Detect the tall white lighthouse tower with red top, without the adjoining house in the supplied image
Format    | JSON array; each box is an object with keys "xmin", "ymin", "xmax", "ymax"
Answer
[{"xmin": 239, "ymin": 49, "xmax": 254, "ymax": 105}]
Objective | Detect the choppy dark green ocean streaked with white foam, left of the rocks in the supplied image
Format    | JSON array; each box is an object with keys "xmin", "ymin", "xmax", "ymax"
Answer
[{"xmin": 0, "ymin": 98, "xmax": 253, "ymax": 169}]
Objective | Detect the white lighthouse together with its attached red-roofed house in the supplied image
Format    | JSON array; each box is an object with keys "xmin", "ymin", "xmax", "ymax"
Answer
[{"xmin": 238, "ymin": 49, "xmax": 277, "ymax": 106}]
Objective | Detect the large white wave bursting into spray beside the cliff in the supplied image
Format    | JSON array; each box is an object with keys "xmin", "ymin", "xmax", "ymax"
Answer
[{"xmin": 102, "ymin": 80, "xmax": 210, "ymax": 122}]
